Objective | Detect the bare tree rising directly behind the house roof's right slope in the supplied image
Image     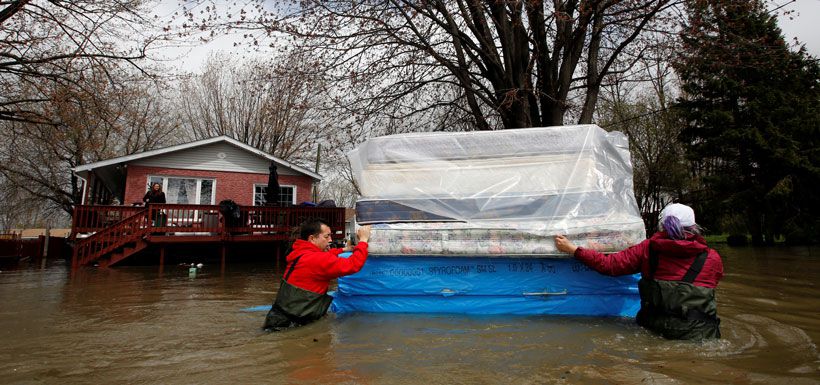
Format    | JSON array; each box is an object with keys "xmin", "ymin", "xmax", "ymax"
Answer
[{"xmin": 179, "ymin": 54, "xmax": 333, "ymax": 165}]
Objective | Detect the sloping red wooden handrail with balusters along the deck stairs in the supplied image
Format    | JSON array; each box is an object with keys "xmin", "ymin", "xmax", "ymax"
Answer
[{"xmin": 72, "ymin": 208, "xmax": 150, "ymax": 268}]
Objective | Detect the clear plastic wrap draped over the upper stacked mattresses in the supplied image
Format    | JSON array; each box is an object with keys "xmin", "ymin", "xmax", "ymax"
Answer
[{"xmin": 348, "ymin": 125, "xmax": 645, "ymax": 256}]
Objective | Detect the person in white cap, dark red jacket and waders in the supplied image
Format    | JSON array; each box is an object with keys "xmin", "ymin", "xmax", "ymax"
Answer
[{"xmin": 555, "ymin": 203, "xmax": 723, "ymax": 340}]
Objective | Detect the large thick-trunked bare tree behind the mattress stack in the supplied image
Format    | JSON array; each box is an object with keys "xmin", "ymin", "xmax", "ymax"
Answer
[{"xmin": 186, "ymin": 0, "xmax": 675, "ymax": 130}]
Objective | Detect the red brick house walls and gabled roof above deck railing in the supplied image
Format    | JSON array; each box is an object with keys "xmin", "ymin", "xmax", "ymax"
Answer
[{"xmin": 74, "ymin": 136, "xmax": 322, "ymax": 206}]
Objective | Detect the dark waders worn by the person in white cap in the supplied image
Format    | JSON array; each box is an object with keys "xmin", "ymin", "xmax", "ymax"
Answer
[{"xmin": 636, "ymin": 250, "xmax": 720, "ymax": 340}]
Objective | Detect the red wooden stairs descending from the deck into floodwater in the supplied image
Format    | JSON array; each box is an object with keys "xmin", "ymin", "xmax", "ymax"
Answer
[{"xmin": 72, "ymin": 209, "xmax": 150, "ymax": 267}]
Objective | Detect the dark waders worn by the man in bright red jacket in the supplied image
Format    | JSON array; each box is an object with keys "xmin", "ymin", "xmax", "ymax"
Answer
[{"xmin": 263, "ymin": 255, "xmax": 333, "ymax": 331}]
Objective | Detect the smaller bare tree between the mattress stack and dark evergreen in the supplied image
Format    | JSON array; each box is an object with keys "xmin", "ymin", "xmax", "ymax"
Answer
[{"xmin": 598, "ymin": 36, "xmax": 691, "ymax": 232}]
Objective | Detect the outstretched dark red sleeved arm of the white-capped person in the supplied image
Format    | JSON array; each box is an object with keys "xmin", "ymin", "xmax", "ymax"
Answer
[{"xmin": 555, "ymin": 235, "xmax": 649, "ymax": 276}]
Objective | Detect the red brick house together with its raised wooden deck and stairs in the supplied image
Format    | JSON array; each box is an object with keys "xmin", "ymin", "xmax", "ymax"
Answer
[{"xmin": 66, "ymin": 136, "xmax": 345, "ymax": 269}]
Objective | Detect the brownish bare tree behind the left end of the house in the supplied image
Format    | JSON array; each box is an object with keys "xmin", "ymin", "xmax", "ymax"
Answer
[{"xmin": 0, "ymin": 71, "xmax": 176, "ymax": 214}]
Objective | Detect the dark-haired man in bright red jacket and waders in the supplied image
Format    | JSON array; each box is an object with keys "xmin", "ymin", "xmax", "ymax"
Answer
[{"xmin": 263, "ymin": 219, "xmax": 370, "ymax": 331}]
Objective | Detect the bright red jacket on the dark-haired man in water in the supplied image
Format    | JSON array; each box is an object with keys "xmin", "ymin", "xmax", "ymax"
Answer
[{"xmin": 283, "ymin": 239, "xmax": 367, "ymax": 294}]
